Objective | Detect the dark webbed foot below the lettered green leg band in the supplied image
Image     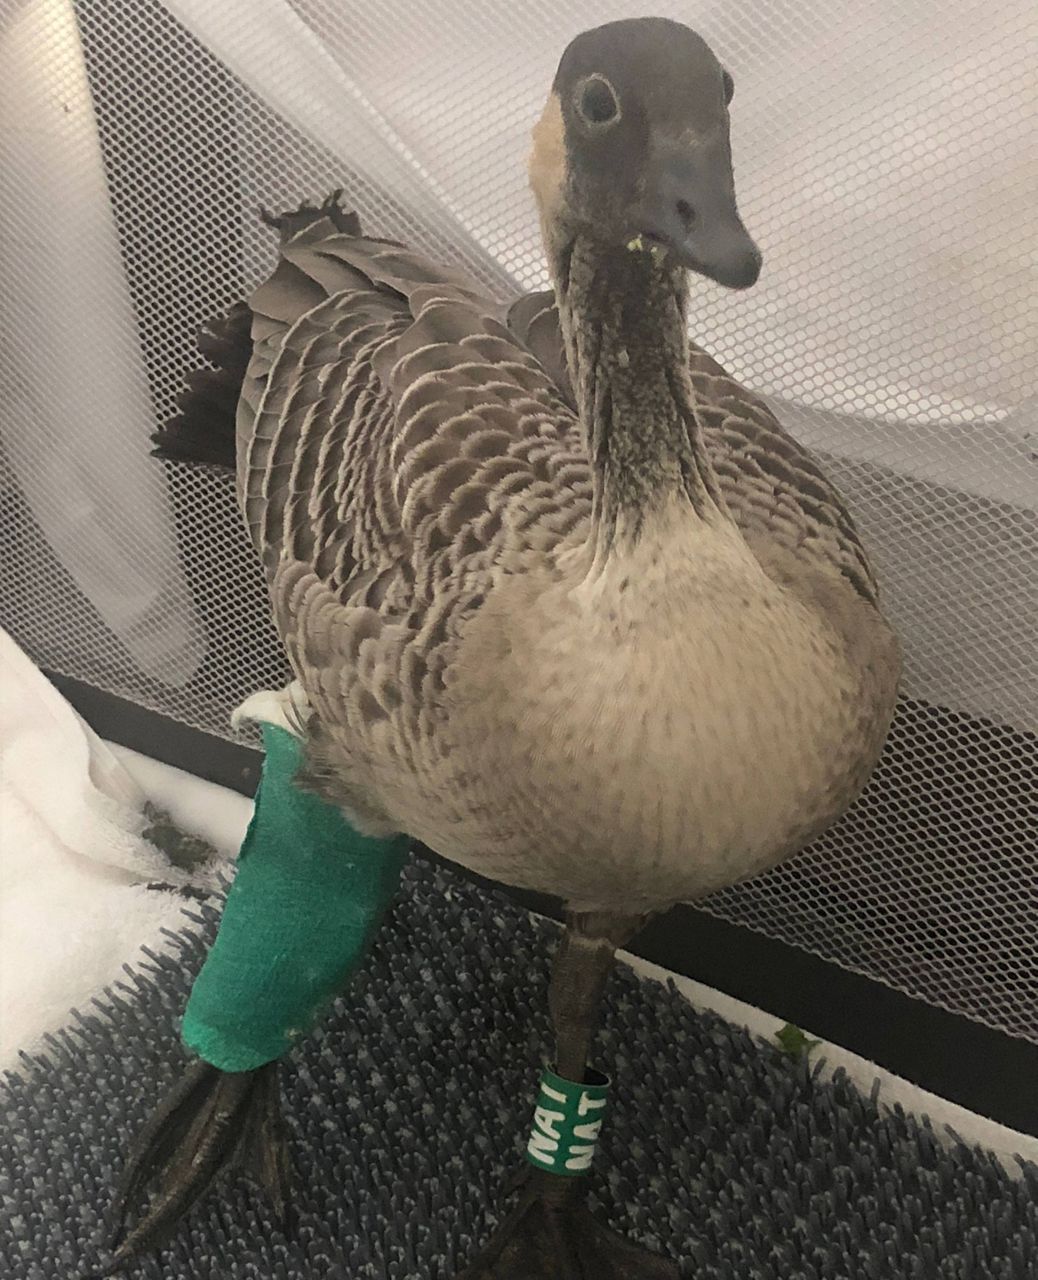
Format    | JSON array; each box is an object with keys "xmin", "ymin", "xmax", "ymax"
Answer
[{"xmin": 458, "ymin": 1172, "xmax": 681, "ymax": 1280}]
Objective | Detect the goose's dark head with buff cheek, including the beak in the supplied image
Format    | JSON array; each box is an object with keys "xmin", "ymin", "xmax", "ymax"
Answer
[{"xmin": 530, "ymin": 18, "xmax": 762, "ymax": 289}]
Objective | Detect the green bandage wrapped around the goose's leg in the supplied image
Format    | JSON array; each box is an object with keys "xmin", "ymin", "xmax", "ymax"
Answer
[{"xmin": 183, "ymin": 724, "xmax": 410, "ymax": 1071}]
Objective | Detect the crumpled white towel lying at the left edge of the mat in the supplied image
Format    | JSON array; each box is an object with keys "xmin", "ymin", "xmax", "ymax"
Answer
[{"xmin": 0, "ymin": 631, "xmax": 243, "ymax": 1068}]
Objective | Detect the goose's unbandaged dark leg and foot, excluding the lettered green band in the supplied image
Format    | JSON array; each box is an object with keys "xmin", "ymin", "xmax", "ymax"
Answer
[{"xmin": 459, "ymin": 914, "xmax": 678, "ymax": 1280}]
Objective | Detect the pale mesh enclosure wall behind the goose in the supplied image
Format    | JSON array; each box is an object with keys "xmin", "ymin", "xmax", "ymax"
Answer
[{"xmin": 0, "ymin": 0, "xmax": 1038, "ymax": 1041}]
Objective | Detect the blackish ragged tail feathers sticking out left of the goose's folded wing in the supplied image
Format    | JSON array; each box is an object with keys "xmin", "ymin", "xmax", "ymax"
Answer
[{"xmin": 152, "ymin": 302, "xmax": 252, "ymax": 471}]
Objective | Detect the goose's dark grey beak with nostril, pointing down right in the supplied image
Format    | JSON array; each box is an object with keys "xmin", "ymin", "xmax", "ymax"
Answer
[{"xmin": 637, "ymin": 138, "xmax": 762, "ymax": 289}]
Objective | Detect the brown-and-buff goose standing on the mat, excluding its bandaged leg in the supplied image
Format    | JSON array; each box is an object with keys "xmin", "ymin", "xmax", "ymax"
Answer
[{"xmin": 111, "ymin": 19, "xmax": 898, "ymax": 1280}]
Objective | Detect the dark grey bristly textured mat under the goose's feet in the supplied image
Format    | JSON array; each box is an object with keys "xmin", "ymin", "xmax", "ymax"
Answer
[{"xmin": 0, "ymin": 864, "xmax": 1038, "ymax": 1280}]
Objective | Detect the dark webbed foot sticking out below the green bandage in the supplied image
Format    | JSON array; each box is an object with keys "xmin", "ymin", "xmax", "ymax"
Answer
[{"xmin": 100, "ymin": 1062, "xmax": 292, "ymax": 1275}]
